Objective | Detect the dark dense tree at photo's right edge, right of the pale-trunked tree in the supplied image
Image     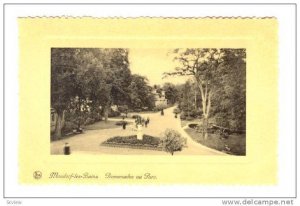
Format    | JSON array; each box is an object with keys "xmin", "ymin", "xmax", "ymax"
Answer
[{"xmin": 212, "ymin": 49, "xmax": 246, "ymax": 130}]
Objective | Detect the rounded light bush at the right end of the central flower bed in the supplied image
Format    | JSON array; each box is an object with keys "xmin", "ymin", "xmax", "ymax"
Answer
[{"xmin": 162, "ymin": 129, "xmax": 186, "ymax": 155}]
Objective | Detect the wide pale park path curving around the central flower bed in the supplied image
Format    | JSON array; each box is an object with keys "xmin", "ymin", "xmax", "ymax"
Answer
[{"xmin": 51, "ymin": 107, "xmax": 226, "ymax": 155}]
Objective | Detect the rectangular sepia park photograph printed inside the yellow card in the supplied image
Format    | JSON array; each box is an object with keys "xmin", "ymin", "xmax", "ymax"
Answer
[{"xmin": 49, "ymin": 48, "xmax": 246, "ymax": 156}]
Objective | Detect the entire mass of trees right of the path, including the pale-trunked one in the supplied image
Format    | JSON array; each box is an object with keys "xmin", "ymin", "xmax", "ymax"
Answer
[{"xmin": 166, "ymin": 48, "xmax": 246, "ymax": 130}]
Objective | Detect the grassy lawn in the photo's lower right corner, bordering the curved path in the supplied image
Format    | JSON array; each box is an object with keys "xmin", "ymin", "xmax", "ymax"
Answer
[{"xmin": 185, "ymin": 128, "xmax": 246, "ymax": 155}]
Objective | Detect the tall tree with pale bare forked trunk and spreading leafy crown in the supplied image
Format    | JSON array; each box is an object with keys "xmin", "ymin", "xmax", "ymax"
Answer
[{"xmin": 165, "ymin": 48, "xmax": 246, "ymax": 135}]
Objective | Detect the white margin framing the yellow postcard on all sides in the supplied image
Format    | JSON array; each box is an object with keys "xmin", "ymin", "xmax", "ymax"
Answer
[{"xmin": 1, "ymin": 2, "xmax": 296, "ymax": 200}]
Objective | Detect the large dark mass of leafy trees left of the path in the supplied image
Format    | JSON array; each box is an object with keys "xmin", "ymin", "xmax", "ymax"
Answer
[{"xmin": 51, "ymin": 48, "xmax": 154, "ymax": 138}]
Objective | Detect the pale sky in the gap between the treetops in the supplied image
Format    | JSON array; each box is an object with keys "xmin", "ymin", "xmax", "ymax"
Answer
[{"xmin": 129, "ymin": 48, "xmax": 188, "ymax": 86}]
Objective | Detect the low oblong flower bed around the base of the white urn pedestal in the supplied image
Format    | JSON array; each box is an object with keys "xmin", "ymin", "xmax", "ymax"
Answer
[{"xmin": 101, "ymin": 135, "xmax": 162, "ymax": 151}]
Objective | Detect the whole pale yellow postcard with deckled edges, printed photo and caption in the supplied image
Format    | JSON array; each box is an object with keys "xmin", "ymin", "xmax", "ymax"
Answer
[{"xmin": 18, "ymin": 17, "xmax": 278, "ymax": 185}]
